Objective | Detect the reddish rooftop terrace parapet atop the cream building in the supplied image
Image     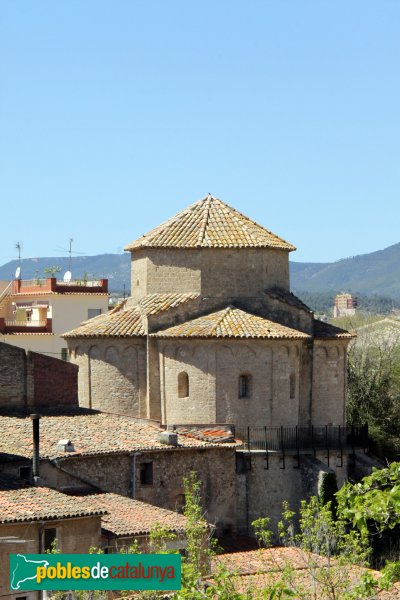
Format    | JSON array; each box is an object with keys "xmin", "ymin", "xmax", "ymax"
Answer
[{"xmin": 11, "ymin": 277, "xmax": 108, "ymax": 295}]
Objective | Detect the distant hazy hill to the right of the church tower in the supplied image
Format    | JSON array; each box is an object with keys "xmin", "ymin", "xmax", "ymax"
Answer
[{"xmin": 290, "ymin": 243, "xmax": 400, "ymax": 300}]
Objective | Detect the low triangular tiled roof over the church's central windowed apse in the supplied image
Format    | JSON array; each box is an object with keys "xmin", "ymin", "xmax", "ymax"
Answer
[{"xmin": 151, "ymin": 306, "xmax": 310, "ymax": 340}]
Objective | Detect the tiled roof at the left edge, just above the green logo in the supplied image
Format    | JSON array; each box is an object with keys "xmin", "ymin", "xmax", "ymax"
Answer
[{"xmin": 0, "ymin": 487, "xmax": 105, "ymax": 523}]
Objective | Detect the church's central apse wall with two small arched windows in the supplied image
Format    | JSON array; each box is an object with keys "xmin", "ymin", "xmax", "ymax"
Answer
[{"xmin": 159, "ymin": 340, "xmax": 303, "ymax": 427}]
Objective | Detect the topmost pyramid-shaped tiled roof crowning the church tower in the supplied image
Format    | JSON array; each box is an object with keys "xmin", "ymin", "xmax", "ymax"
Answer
[{"xmin": 125, "ymin": 195, "xmax": 296, "ymax": 252}]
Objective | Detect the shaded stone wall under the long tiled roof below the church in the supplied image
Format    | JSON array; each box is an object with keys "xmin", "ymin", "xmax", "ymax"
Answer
[{"xmin": 45, "ymin": 446, "xmax": 236, "ymax": 529}]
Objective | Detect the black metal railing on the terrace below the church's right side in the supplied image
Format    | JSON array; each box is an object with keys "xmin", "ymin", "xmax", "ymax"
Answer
[{"xmin": 235, "ymin": 425, "xmax": 368, "ymax": 453}]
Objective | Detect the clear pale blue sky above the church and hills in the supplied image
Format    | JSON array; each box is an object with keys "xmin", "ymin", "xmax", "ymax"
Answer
[{"xmin": 0, "ymin": 0, "xmax": 400, "ymax": 264}]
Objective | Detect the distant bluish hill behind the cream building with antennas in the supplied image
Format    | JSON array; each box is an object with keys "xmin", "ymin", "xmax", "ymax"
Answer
[{"xmin": 0, "ymin": 254, "xmax": 131, "ymax": 292}]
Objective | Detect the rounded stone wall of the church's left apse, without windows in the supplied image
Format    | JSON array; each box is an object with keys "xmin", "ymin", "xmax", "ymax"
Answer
[{"xmin": 68, "ymin": 339, "xmax": 147, "ymax": 417}]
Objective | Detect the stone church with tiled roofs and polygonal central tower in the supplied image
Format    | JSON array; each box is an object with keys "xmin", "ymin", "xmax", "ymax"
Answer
[{"xmin": 64, "ymin": 195, "xmax": 352, "ymax": 427}]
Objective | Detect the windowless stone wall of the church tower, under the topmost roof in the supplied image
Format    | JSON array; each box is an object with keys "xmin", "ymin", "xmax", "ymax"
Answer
[{"xmin": 131, "ymin": 248, "xmax": 289, "ymax": 299}]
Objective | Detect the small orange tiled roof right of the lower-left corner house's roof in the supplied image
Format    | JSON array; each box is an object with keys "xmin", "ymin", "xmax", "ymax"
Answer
[{"xmin": 85, "ymin": 494, "xmax": 187, "ymax": 536}]
